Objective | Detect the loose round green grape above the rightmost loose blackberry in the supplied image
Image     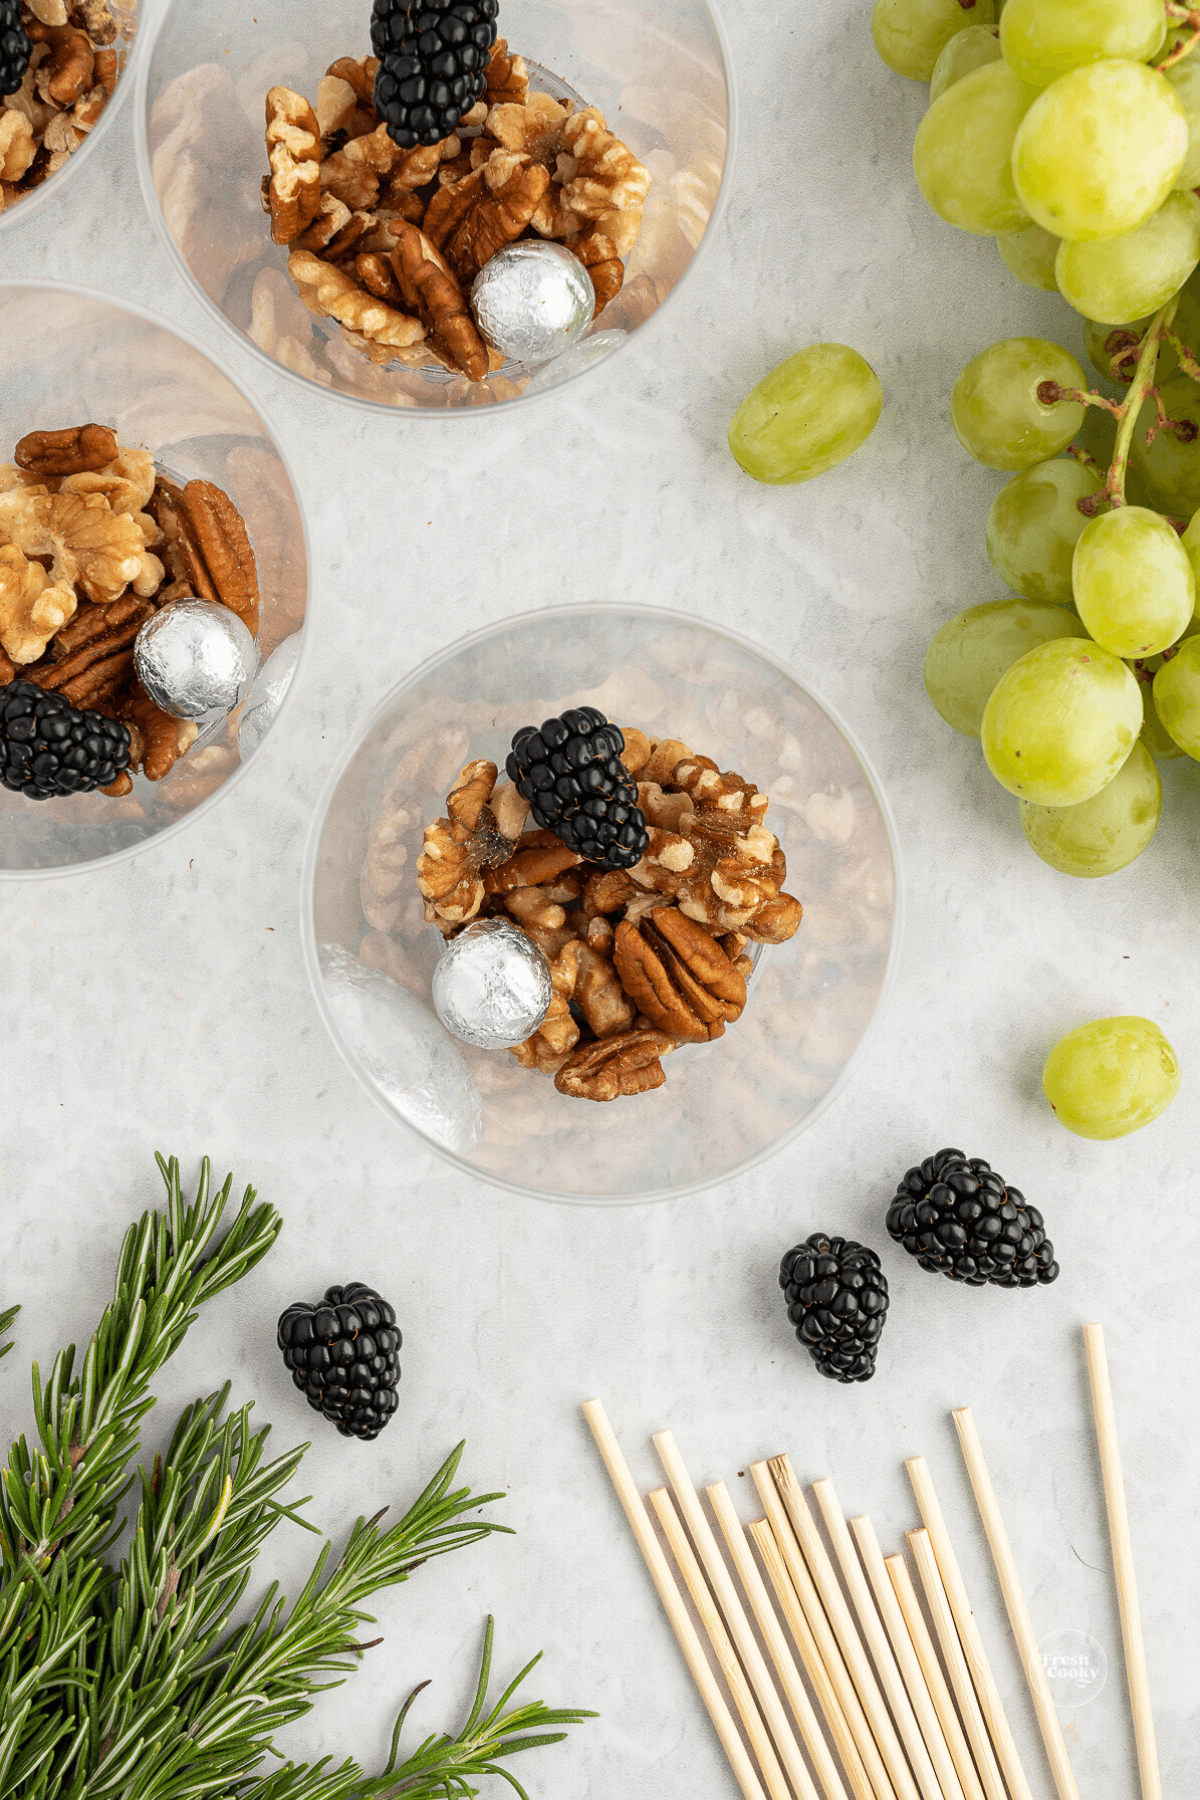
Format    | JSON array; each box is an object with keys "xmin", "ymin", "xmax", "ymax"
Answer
[{"xmin": 1042, "ymin": 1015, "xmax": 1178, "ymax": 1138}]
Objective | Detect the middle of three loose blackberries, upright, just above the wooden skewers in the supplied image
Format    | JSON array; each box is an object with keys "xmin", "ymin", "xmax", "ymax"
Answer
[{"xmin": 779, "ymin": 1231, "xmax": 887, "ymax": 1381}]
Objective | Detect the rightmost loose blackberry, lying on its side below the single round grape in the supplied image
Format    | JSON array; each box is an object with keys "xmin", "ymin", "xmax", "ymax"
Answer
[{"xmin": 887, "ymin": 1150, "xmax": 1058, "ymax": 1287}]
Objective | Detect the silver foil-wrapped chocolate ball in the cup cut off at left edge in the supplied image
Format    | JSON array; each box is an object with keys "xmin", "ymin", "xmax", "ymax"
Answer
[{"xmin": 133, "ymin": 599, "xmax": 259, "ymax": 718}]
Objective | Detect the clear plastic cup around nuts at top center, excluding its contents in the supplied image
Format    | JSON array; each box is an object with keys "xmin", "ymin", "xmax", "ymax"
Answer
[{"xmin": 135, "ymin": 0, "xmax": 736, "ymax": 416}]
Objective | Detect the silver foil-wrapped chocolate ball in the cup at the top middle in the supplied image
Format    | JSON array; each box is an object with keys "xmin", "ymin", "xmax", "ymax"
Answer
[{"xmin": 471, "ymin": 239, "xmax": 596, "ymax": 362}]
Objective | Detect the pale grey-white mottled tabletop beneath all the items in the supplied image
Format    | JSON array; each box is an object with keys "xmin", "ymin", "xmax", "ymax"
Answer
[{"xmin": 0, "ymin": 0, "xmax": 1200, "ymax": 1800}]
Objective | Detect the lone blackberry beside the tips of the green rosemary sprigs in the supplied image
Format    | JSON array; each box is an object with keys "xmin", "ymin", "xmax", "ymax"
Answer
[{"xmin": 277, "ymin": 1282, "xmax": 403, "ymax": 1440}]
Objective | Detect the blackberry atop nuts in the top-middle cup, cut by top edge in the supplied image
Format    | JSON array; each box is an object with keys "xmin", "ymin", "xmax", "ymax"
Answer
[{"xmin": 371, "ymin": 0, "xmax": 500, "ymax": 149}]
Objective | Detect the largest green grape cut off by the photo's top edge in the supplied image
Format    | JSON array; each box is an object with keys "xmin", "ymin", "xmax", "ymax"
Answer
[{"xmin": 1000, "ymin": 0, "xmax": 1166, "ymax": 88}]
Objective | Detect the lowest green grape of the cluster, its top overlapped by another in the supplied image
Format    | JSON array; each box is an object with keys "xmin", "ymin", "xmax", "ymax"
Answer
[{"xmin": 1018, "ymin": 743, "xmax": 1162, "ymax": 880}]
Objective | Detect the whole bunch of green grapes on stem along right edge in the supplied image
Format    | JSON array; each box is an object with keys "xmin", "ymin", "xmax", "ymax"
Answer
[{"xmin": 871, "ymin": 0, "xmax": 1200, "ymax": 877}]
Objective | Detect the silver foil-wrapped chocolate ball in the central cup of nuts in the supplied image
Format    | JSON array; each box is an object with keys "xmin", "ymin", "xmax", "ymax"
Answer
[{"xmin": 434, "ymin": 918, "xmax": 552, "ymax": 1049}]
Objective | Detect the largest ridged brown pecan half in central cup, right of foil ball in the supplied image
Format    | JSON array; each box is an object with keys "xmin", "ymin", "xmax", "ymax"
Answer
[{"xmin": 613, "ymin": 907, "xmax": 747, "ymax": 1044}]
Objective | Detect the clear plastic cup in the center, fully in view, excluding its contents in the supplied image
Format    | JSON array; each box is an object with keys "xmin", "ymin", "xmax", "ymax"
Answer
[{"xmin": 302, "ymin": 607, "xmax": 900, "ymax": 1202}]
